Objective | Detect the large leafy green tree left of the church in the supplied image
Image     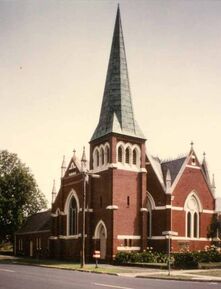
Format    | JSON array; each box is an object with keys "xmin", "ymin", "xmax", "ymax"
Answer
[{"xmin": 0, "ymin": 150, "xmax": 47, "ymax": 241}]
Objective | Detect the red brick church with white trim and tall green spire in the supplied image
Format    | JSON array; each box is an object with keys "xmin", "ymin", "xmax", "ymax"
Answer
[{"xmin": 15, "ymin": 8, "xmax": 218, "ymax": 260}]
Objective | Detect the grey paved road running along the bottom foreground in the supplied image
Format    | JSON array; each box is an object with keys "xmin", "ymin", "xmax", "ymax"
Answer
[{"xmin": 0, "ymin": 264, "xmax": 221, "ymax": 289}]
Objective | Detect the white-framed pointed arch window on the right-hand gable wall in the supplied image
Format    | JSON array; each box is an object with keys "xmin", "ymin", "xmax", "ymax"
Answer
[{"xmin": 184, "ymin": 192, "xmax": 202, "ymax": 238}]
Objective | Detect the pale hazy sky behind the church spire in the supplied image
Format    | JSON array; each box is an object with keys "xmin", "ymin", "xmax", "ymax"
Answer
[{"xmin": 0, "ymin": 0, "xmax": 221, "ymax": 204}]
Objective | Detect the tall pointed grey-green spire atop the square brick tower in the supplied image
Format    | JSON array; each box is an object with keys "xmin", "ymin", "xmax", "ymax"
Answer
[{"xmin": 91, "ymin": 6, "xmax": 145, "ymax": 140}]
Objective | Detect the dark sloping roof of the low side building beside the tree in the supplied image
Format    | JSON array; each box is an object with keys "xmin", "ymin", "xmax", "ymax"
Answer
[{"xmin": 16, "ymin": 210, "xmax": 51, "ymax": 234}]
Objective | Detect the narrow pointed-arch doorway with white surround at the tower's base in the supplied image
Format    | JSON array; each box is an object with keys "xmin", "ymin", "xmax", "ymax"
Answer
[{"xmin": 95, "ymin": 221, "xmax": 107, "ymax": 259}]
